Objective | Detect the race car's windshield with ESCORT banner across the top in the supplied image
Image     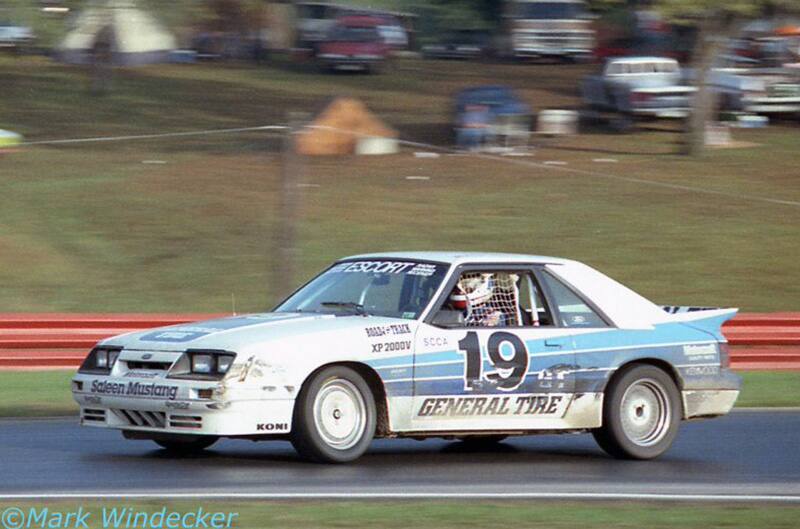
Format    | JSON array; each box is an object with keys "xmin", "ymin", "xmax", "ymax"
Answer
[{"xmin": 275, "ymin": 259, "xmax": 448, "ymax": 319}]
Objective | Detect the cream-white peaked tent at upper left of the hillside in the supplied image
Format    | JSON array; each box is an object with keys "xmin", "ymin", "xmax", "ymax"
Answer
[{"xmin": 57, "ymin": 0, "xmax": 176, "ymax": 65}]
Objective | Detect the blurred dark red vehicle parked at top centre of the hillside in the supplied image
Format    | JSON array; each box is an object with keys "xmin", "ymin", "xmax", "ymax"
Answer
[{"xmin": 317, "ymin": 15, "xmax": 389, "ymax": 72}]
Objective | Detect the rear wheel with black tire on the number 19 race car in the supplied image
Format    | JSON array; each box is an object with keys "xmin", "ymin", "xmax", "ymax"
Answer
[{"xmin": 592, "ymin": 364, "xmax": 681, "ymax": 459}]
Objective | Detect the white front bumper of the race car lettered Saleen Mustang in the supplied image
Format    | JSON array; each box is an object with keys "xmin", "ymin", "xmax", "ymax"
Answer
[{"xmin": 72, "ymin": 374, "xmax": 294, "ymax": 436}]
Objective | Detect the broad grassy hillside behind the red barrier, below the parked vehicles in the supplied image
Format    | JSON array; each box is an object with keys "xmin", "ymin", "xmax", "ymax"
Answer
[{"xmin": 0, "ymin": 58, "xmax": 800, "ymax": 312}]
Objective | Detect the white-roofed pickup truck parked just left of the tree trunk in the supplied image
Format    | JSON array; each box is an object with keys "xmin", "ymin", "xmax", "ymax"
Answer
[{"xmin": 581, "ymin": 57, "xmax": 695, "ymax": 129}]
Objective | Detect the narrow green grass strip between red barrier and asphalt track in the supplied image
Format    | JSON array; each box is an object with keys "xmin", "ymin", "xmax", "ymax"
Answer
[{"xmin": 0, "ymin": 370, "xmax": 800, "ymax": 417}]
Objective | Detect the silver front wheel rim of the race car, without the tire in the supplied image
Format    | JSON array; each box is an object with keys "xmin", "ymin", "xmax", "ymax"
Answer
[{"xmin": 314, "ymin": 378, "xmax": 367, "ymax": 450}]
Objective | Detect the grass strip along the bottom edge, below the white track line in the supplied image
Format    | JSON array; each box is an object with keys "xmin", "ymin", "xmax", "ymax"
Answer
[{"xmin": 0, "ymin": 501, "xmax": 800, "ymax": 529}]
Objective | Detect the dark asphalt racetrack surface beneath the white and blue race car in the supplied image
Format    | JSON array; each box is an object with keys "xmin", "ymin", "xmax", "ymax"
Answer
[{"xmin": 0, "ymin": 411, "xmax": 800, "ymax": 501}]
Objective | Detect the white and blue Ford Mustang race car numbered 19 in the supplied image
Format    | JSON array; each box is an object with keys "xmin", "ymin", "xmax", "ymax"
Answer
[{"xmin": 72, "ymin": 252, "xmax": 740, "ymax": 462}]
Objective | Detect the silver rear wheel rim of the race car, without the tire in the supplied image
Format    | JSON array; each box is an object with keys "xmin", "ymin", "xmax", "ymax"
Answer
[{"xmin": 620, "ymin": 378, "xmax": 672, "ymax": 446}]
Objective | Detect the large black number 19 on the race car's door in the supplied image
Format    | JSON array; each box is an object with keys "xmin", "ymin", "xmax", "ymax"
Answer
[{"xmin": 458, "ymin": 331, "xmax": 529, "ymax": 391}]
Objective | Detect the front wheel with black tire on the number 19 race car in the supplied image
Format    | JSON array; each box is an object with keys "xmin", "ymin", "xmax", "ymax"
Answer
[{"xmin": 290, "ymin": 366, "xmax": 377, "ymax": 463}]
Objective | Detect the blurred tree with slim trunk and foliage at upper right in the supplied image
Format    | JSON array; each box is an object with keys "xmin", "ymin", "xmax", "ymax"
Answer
[{"xmin": 652, "ymin": 0, "xmax": 800, "ymax": 155}]
